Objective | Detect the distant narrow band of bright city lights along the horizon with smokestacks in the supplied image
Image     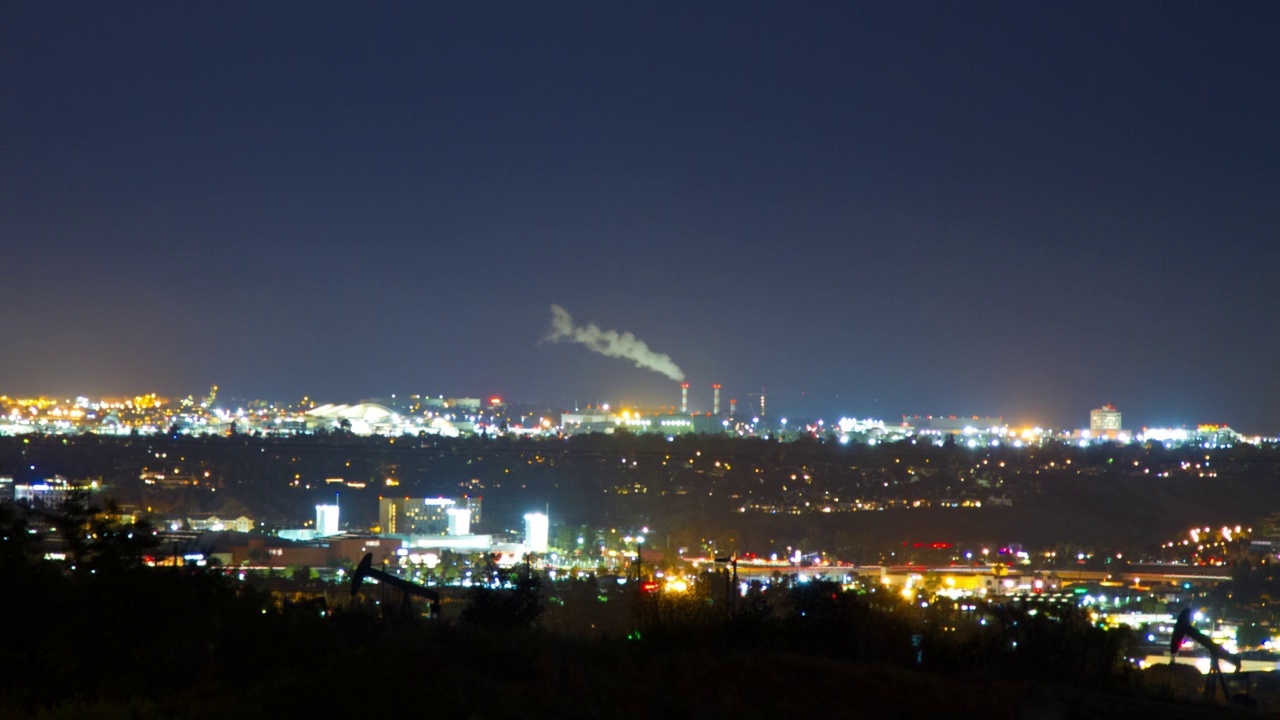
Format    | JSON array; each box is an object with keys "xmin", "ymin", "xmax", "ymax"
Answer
[{"xmin": 0, "ymin": 384, "xmax": 1276, "ymax": 447}]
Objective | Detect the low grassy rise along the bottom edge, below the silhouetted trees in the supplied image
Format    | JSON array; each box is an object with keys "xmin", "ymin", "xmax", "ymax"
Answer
[{"xmin": 0, "ymin": 638, "xmax": 1258, "ymax": 720}]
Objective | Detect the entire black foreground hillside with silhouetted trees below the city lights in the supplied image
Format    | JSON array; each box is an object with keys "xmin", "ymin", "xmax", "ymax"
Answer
[{"xmin": 0, "ymin": 555, "xmax": 1274, "ymax": 720}]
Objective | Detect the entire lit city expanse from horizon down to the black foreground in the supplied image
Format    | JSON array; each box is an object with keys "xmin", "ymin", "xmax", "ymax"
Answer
[{"xmin": 10, "ymin": 376, "xmax": 1280, "ymax": 712}]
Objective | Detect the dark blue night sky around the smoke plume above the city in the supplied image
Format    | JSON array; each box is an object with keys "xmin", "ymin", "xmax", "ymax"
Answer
[{"xmin": 0, "ymin": 1, "xmax": 1280, "ymax": 433}]
